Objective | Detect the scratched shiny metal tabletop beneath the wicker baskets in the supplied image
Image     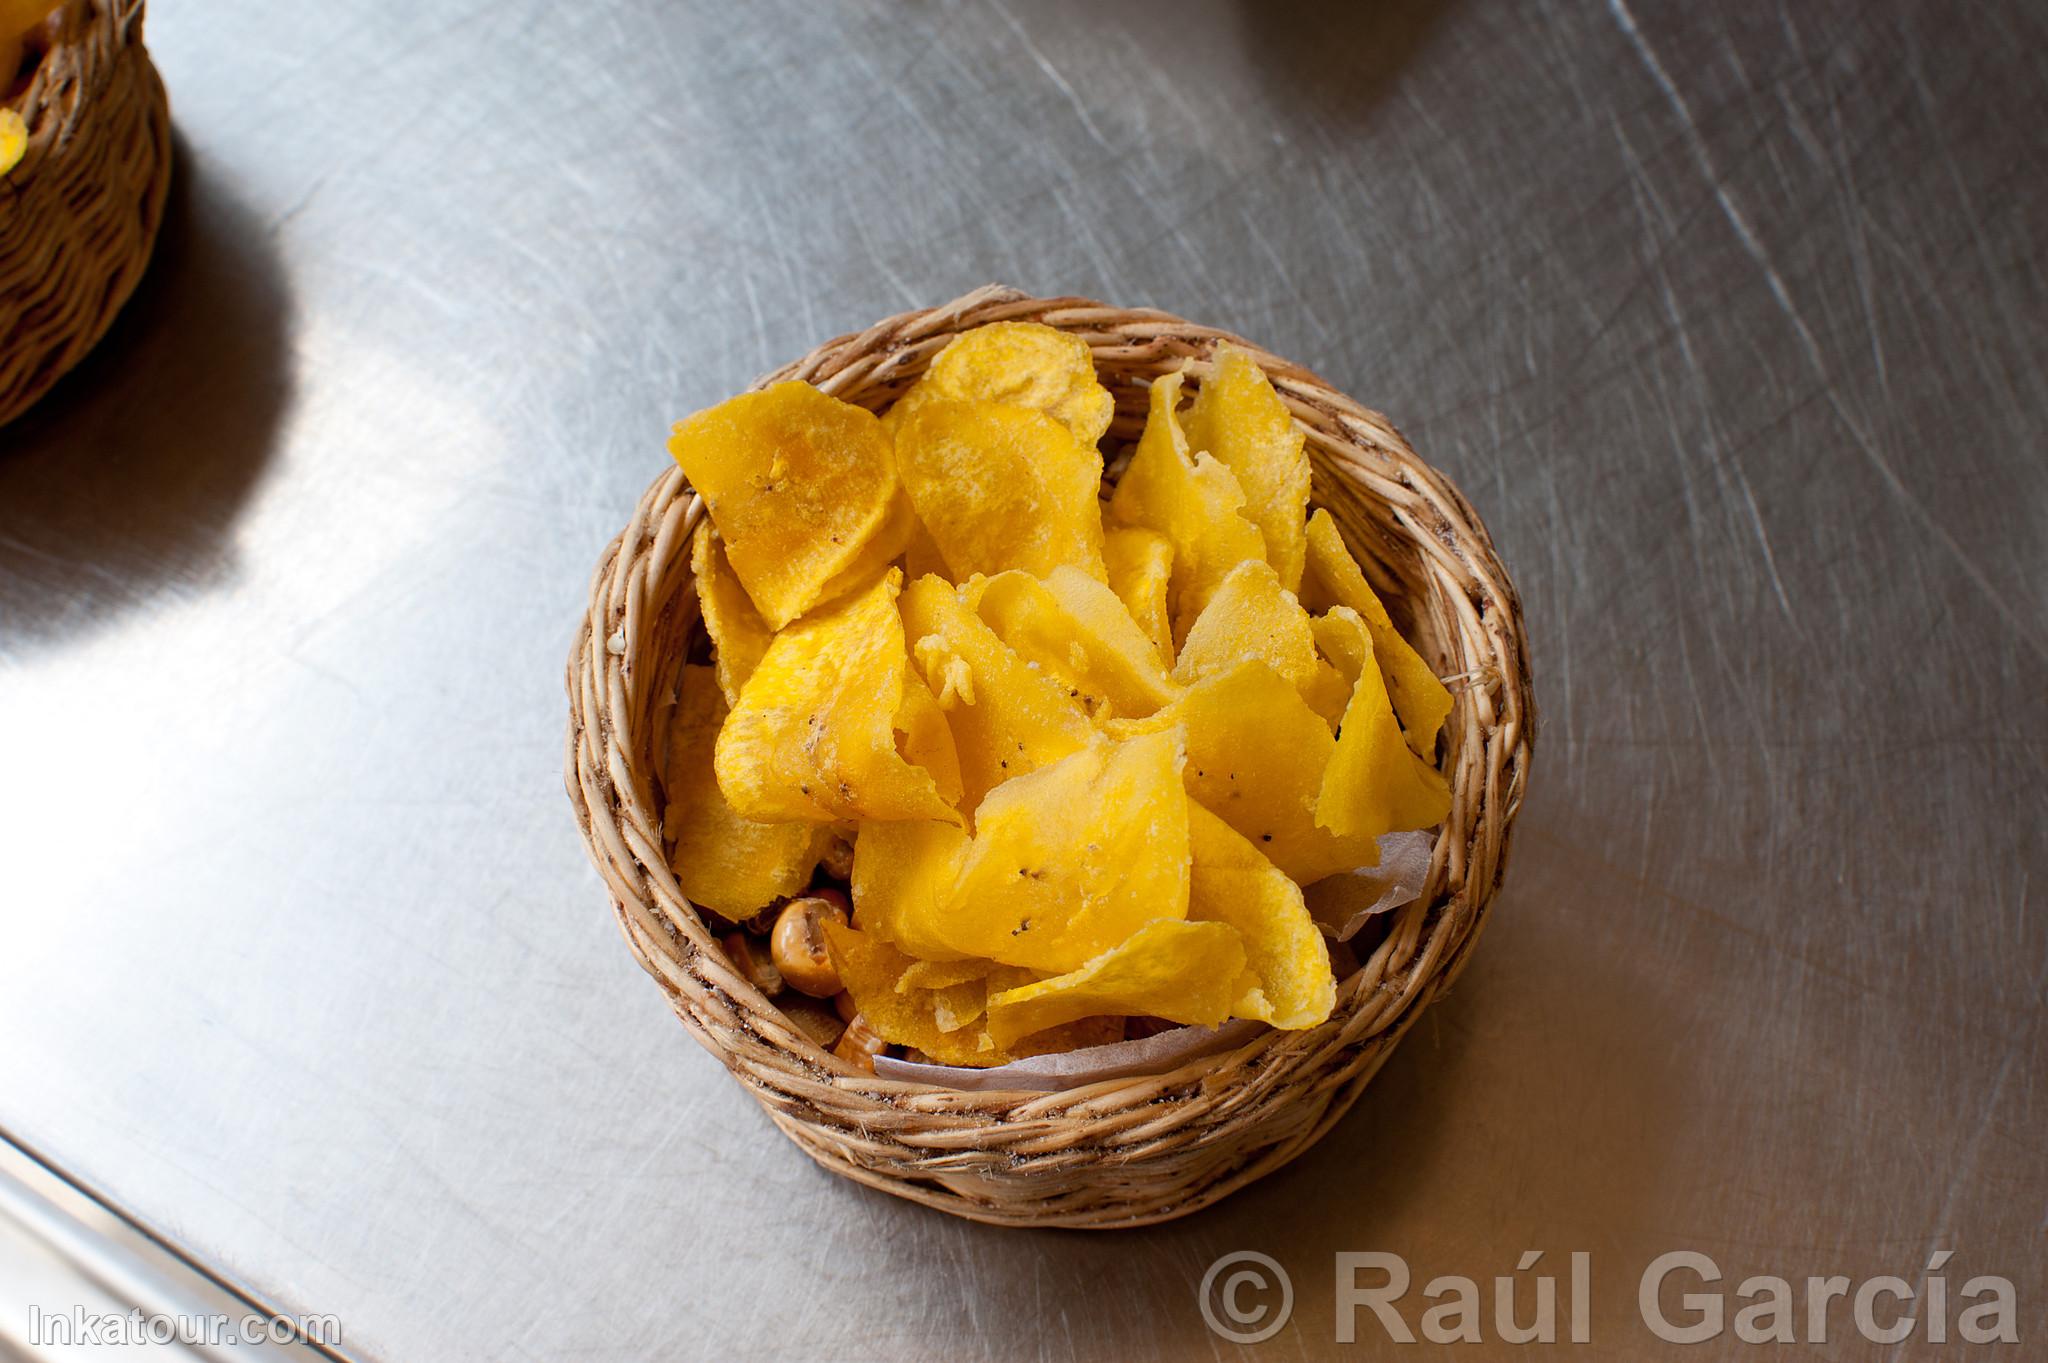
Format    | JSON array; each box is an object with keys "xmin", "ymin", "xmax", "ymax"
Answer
[{"xmin": 0, "ymin": 0, "xmax": 2048, "ymax": 1359}]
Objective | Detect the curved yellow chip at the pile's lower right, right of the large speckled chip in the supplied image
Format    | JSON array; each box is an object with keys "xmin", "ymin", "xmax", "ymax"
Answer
[{"xmin": 1188, "ymin": 804, "xmax": 1337, "ymax": 1031}]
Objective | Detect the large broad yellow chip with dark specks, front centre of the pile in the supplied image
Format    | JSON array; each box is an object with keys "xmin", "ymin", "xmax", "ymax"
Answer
[{"xmin": 934, "ymin": 731, "xmax": 1188, "ymax": 972}]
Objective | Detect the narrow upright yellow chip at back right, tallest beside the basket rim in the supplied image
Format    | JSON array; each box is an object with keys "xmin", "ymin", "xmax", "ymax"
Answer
[{"xmin": 1182, "ymin": 346, "xmax": 1309, "ymax": 591}]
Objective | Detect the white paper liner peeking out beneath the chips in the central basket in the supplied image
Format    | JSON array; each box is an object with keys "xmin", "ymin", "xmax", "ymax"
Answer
[{"xmin": 874, "ymin": 831, "xmax": 1436, "ymax": 1093}]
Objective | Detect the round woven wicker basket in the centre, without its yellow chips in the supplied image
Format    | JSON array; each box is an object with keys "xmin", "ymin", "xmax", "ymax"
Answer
[{"xmin": 567, "ymin": 287, "xmax": 1534, "ymax": 1226}]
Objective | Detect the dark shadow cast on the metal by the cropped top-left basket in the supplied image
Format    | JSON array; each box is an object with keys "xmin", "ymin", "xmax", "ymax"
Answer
[{"xmin": 0, "ymin": 139, "xmax": 291, "ymax": 649}]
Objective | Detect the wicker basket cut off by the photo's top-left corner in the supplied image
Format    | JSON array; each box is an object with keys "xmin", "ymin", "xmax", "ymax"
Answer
[{"xmin": 0, "ymin": 0, "xmax": 170, "ymax": 424}]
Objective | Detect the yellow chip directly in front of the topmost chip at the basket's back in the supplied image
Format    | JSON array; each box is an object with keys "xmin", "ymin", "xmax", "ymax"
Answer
[{"xmin": 895, "ymin": 399, "xmax": 1104, "ymax": 581}]
